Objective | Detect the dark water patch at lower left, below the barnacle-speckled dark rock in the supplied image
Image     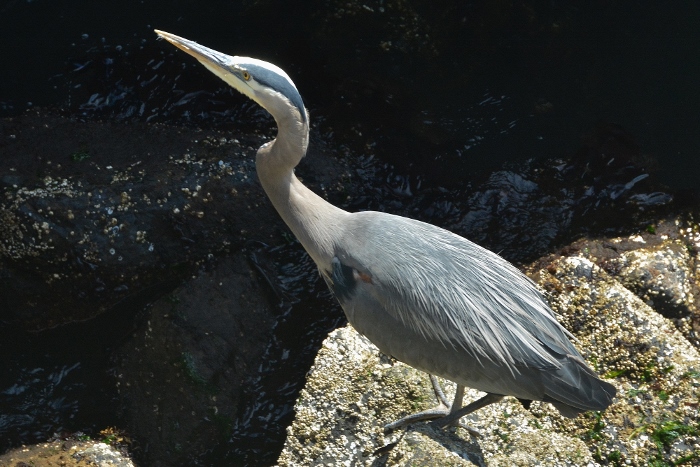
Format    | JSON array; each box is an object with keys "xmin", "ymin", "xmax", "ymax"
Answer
[{"xmin": 0, "ymin": 302, "xmax": 135, "ymax": 451}]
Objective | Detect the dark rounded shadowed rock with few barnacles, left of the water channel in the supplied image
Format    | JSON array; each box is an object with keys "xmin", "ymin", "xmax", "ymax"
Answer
[{"xmin": 113, "ymin": 255, "xmax": 278, "ymax": 466}]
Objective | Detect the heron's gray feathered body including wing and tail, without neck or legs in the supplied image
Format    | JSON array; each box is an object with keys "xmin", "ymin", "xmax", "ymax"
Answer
[{"xmin": 324, "ymin": 212, "xmax": 614, "ymax": 416}]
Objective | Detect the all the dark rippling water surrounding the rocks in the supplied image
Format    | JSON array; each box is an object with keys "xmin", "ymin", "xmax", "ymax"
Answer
[{"xmin": 0, "ymin": 0, "xmax": 700, "ymax": 464}]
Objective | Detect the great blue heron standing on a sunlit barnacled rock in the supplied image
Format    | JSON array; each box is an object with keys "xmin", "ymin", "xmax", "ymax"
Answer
[{"xmin": 156, "ymin": 30, "xmax": 615, "ymax": 436}]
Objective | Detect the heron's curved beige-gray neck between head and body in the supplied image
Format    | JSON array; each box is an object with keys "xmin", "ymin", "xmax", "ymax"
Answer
[{"xmin": 255, "ymin": 126, "xmax": 348, "ymax": 270}]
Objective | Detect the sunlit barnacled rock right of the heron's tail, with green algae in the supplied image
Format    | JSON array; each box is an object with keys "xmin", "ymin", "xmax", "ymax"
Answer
[{"xmin": 539, "ymin": 256, "xmax": 700, "ymax": 465}]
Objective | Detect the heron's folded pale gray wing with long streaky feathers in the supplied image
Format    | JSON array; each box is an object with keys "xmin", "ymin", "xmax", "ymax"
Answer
[{"xmin": 336, "ymin": 212, "xmax": 579, "ymax": 373}]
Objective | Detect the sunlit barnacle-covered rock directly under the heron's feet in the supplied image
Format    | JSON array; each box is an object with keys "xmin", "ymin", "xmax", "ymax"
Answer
[{"xmin": 278, "ymin": 326, "xmax": 591, "ymax": 466}]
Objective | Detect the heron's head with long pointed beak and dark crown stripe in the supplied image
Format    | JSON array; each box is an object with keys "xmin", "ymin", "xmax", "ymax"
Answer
[{"xmin": 155, "ymin": 29, "xmax": 308, "ymax": 125}]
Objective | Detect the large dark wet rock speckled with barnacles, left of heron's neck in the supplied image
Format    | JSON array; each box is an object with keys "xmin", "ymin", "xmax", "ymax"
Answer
[{"xmin": 0, "ymin": 113, "xmax": 339, "ymax": 329}]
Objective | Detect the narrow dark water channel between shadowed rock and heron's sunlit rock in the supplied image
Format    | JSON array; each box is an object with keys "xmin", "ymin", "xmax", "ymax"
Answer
[{"xmin": 209, "ymin": 242, "xmax": 347, "ymax": 465}]
